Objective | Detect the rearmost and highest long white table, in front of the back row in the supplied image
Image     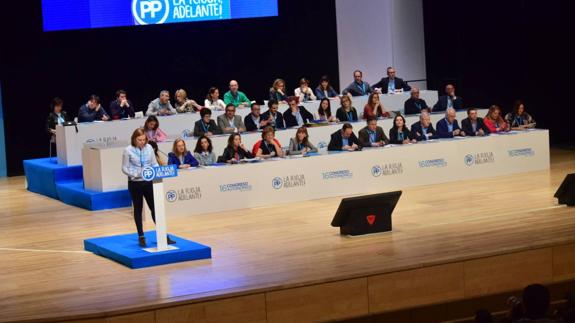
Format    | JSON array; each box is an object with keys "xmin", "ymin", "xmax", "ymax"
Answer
[{"xmin": 56, "ymin": 91, "xmax": 437, "ymax": 166}]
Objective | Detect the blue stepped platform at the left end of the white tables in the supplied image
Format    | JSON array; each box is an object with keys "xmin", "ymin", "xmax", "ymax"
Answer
[{"xmin": 24, "ymin": 158, "xmax": 132, "ymax": 211}]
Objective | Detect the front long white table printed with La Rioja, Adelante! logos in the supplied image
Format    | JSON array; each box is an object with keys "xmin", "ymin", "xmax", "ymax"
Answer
[{"xmin": 164, "ymin": 130, "xmax": 549, "ymax": 215}]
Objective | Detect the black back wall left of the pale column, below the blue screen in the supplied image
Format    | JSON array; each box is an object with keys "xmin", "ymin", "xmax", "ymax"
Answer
[{"xmin": 0, "ymin": 0, "xmax": 339, "ymax": 175}]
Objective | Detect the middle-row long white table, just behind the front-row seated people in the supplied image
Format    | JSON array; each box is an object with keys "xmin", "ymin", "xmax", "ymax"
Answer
[{"xmin": 82, "ymin": 110, "xmax": 472, "ymax": 192}]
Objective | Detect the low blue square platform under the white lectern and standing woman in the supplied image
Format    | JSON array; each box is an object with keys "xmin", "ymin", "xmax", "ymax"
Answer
[{"xmin": 84, "ymin": 231, "xmax": 212, "ymax": 269}]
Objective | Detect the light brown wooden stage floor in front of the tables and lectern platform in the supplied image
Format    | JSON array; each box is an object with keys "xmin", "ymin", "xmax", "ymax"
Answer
[{"xmin": 0, "ymin": 149, "xmax": 575, "ymax": 322}]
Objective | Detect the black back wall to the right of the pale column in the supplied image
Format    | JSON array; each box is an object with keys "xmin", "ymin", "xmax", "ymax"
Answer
[{"xmin": 423, "ymin": 0, "xmax": 575, "ymax": 143}]
